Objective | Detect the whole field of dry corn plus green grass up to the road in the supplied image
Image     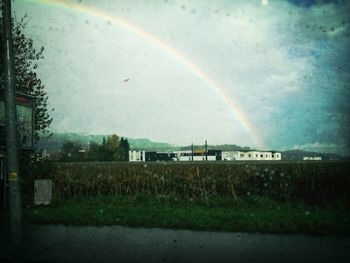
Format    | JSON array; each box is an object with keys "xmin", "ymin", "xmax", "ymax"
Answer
[{"xmin": 19, "ymin": 161, "xmax": 350, "ymax": 235}]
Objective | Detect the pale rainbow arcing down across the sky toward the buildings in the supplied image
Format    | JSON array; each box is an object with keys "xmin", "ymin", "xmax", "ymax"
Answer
[{"xmin": 26, "ymin": 0, "xmax": 266, "ymax": 148}]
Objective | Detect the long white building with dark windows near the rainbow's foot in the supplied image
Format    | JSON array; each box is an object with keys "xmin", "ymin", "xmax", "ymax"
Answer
[{"xmin": 221, "ymin": 151, "xmax": 282, "ymax": 161}]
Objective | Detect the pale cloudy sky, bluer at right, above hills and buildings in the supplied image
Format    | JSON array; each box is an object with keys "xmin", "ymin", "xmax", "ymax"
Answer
[{"xmin": 13, "ymin": 0, "xmax": 350, "ymax": 154}]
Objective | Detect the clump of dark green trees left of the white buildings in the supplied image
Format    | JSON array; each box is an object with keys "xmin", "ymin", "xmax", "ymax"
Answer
[{"xmin": 58, "ymin": 134, "xmax": 130, "ymax": 162}]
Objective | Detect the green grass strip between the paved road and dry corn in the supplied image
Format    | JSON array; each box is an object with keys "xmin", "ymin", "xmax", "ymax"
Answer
[{"xmin": 19, "ymin": 195, "xmax": 350, "ymax": 235}]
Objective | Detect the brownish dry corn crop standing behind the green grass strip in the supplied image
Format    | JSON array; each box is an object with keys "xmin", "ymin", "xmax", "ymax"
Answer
[{"xmin": 44, "ymin": 162, "xmax": 350, "ymax": 203}]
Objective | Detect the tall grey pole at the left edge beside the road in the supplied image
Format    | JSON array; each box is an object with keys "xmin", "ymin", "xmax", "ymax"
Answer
[{"xmin": 2, "ymin": 0, "xmax": 22, "ymax": 262}]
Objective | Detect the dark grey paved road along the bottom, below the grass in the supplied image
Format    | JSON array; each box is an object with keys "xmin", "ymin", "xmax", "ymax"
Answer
[{"xmin": 0, "ymin": 225, "xmax": 350, "ymax": 263}]
